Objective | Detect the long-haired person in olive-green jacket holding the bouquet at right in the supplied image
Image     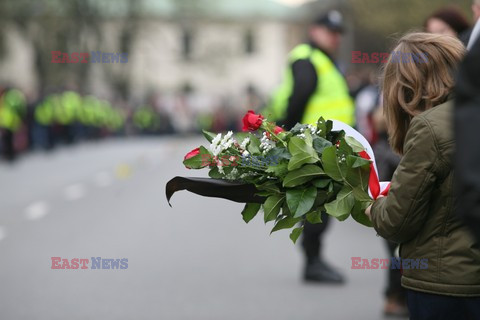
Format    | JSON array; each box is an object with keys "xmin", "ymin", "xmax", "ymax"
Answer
[{"xmin": 366, "ymin": 33, "xmax": 480, "ymax": 320}]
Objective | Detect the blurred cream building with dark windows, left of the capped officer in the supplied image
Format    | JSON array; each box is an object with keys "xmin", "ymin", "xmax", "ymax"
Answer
[{"xmin": 129, "ymin": 0, "xmax": 303, "ymax": 109}]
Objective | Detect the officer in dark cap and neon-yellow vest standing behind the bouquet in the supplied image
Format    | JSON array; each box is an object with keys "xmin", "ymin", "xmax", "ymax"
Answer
[{"xmin": 264, "ymin": 10, "xmax": 355, "ymax": 284}]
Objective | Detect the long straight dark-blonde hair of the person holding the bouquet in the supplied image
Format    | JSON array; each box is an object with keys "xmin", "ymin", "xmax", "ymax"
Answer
[{"xmin": 382, "ymin": 32, "xmax": 465, "ymax": 154}]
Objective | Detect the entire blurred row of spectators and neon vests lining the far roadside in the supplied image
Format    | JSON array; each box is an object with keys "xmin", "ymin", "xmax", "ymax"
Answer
[{"xmin": 0, "ymin": 87, "xmax": 261, "ymax": 162}]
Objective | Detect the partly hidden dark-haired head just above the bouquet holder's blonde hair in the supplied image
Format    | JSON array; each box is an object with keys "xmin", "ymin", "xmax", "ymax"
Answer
[{"xmin": 424, "ymin": 7, "xmax": 470, "ymax": 45}]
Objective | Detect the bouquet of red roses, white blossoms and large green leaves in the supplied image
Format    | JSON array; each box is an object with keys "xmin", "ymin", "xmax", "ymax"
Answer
[{"xmin": 171, "ymin": 111, "xmax": 388, "ymax": 242}]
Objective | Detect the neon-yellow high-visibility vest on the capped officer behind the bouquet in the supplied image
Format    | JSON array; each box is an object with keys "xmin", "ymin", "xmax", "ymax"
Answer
[{"xmin": 266, "ymin": 44, "xmax": 355, "ymax": 126}]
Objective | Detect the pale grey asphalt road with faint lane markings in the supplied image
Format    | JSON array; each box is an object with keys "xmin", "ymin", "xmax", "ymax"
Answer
[{"xmin": 0, "ymin": 137, "xmax": 398, "ymax": 320}]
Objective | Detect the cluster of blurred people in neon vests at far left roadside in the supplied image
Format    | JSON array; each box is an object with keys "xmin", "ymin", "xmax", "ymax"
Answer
[{"xmin": 0, "ymin": 88, "xmax": 128, "ymax": 161}]
